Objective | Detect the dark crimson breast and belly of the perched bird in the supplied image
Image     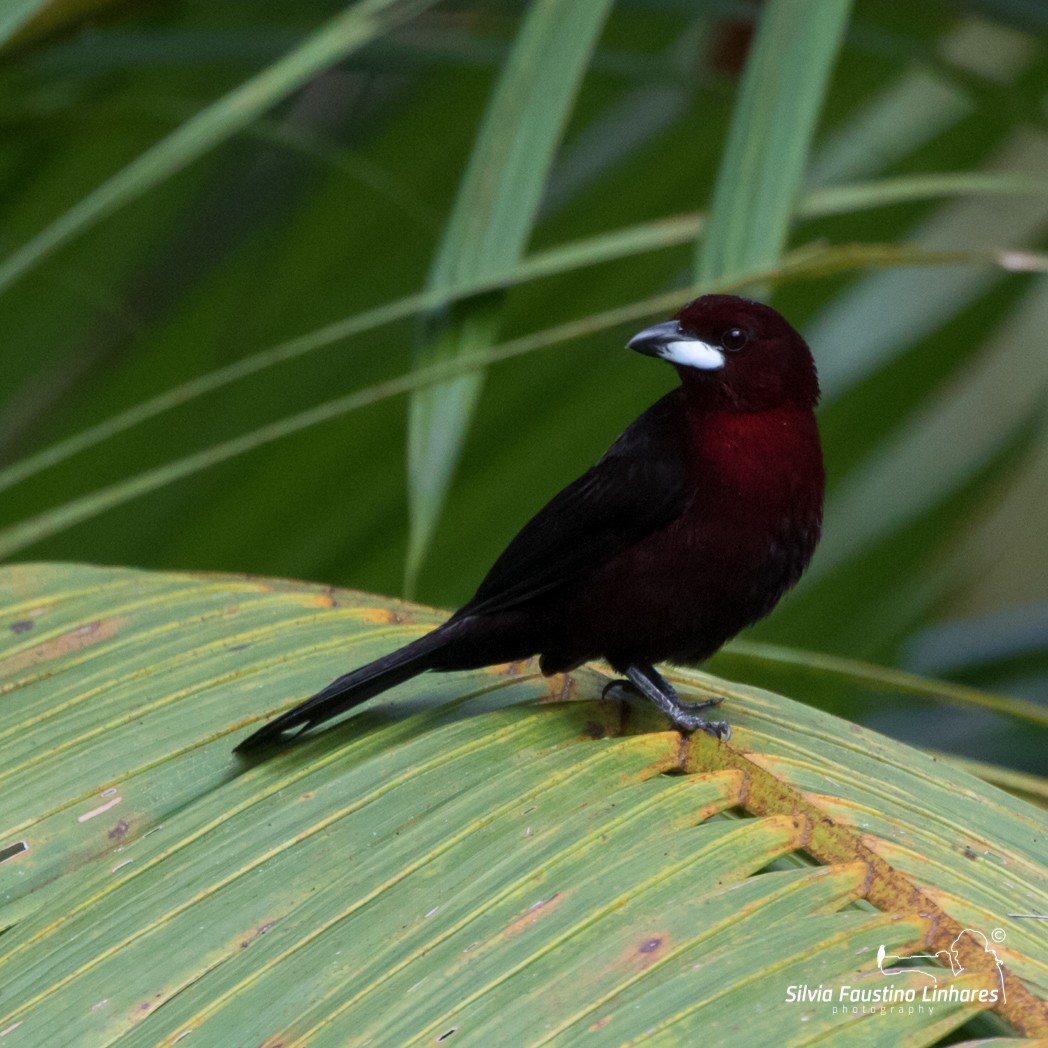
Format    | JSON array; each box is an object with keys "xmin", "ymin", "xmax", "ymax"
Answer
[{"xmin": 553, "ymin": 404, "xmax": 823, "ymax": 665}]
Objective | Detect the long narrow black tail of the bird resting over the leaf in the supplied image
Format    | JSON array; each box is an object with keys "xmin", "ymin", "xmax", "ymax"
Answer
[{"xmin": 234, "ymin": 627, "xmax": 447, "ymax": 754}]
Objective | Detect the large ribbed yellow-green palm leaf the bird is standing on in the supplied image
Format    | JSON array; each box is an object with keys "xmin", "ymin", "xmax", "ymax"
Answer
[{"xmin": 0, "ymin": 565, "xmax": 1048, "ymax": 1046}]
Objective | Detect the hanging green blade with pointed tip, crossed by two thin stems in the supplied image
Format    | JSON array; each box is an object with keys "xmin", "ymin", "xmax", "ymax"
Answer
[{"xmin": 406, "ymin": 0, "xmax": 611, "ymax": 592}]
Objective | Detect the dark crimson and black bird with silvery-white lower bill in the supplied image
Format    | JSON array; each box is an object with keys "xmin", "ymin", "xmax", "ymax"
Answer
[{"xmin": 237, "ymin": 294, "xmax": 825, "ymax": 754}]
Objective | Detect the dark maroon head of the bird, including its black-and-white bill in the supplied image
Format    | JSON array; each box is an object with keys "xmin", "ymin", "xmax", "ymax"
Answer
[{"xmin": 627, "ymin": 294, "xmax": 818, "ymax": 411}]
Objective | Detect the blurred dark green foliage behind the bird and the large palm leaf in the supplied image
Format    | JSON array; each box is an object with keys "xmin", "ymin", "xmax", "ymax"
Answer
[{"xmin": 0, "ymin": 0, "xmax": 1048, "ymax": 771}]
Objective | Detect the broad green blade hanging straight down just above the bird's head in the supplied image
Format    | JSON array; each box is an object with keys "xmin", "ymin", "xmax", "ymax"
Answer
[{"xmin": 696, "ymin": 0, "xmax": 851, "ymax": 280}]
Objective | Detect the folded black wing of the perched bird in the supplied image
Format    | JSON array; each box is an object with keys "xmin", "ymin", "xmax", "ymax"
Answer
[{"xmin": 455, "ymin": 390, "xmax": 693, "ymax": 617}]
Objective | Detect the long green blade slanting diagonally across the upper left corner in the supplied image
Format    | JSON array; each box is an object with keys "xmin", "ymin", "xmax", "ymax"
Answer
[{"xmin": 0, "ymin": 0, "xmax": 437, "ymax": 292}]
